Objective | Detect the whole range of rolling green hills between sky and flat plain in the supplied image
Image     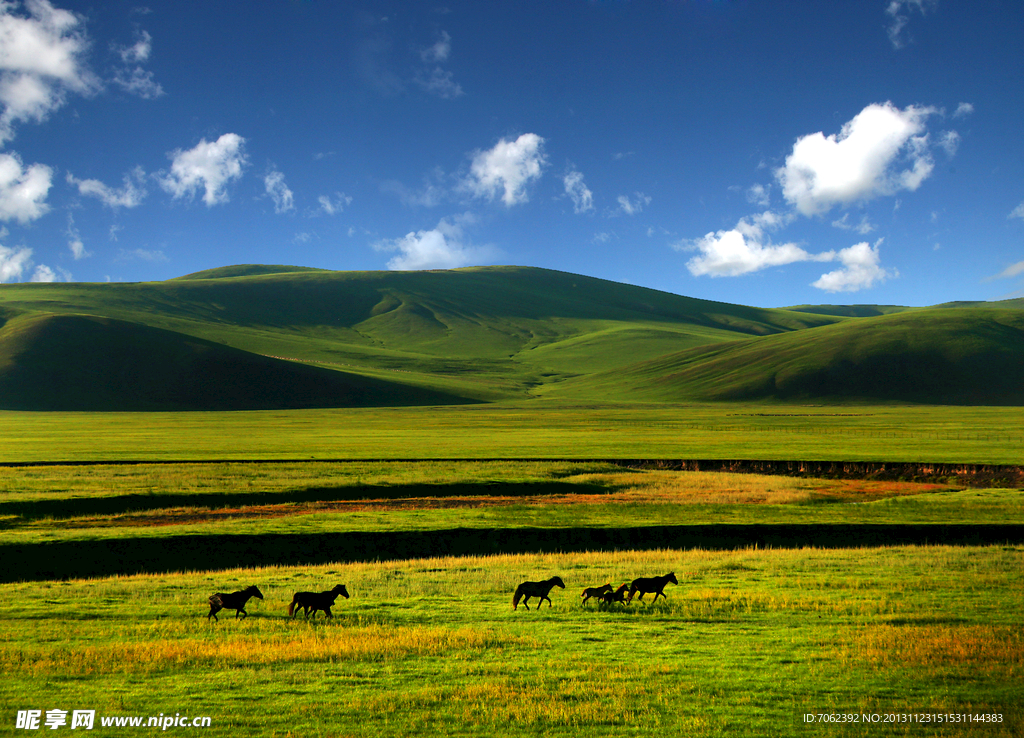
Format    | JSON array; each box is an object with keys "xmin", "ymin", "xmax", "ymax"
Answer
[{"xmin": 0, "ymin": 264, "xmax": 1024, "ymax": 409}]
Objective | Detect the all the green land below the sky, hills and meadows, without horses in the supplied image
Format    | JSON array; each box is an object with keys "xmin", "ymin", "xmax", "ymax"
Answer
[{"xmin": 0, "ymin": 265, "xmax": 1024, "ymax": 737}]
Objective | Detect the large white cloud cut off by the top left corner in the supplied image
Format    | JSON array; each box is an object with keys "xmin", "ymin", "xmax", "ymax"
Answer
[{"xmin": 0, "ymin": 0, "xmax": 99, "ymax": 143}]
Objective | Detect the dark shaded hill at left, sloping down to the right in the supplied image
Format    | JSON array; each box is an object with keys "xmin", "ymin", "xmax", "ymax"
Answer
[{"xmin": 0, "ymin": 315, "xmax": 463, "ymax": 410}]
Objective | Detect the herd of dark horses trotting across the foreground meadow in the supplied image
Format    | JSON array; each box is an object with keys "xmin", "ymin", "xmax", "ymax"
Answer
[{"xmin": 206, "ymin": 572, "xmax": 679, "ymax": 620}]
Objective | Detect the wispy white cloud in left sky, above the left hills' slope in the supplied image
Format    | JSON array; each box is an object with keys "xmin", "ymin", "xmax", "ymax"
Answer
[{"xmin": 160, "ymin": 133, "xmax": 248, "ymax": 207}]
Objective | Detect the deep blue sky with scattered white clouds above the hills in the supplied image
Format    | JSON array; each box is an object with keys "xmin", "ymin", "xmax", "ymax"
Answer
[{"xmin": 0, "ymin": 0, "xmax": 1024, "ymax": 306}]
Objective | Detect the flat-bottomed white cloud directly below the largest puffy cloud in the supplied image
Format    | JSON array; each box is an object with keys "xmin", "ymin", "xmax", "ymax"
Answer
[{"xmin": 675, "ymin": 211, "xmax": 835, "ymax": 276}]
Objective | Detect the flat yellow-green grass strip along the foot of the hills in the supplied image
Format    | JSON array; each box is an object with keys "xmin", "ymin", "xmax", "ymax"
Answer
[{"xmin": 0, "ymin": 402, "xmax": 1024, "ymax": 464}]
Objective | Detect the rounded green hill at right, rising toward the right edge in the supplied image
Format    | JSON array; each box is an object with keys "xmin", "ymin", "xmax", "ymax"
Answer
[{"xmin": 552, "ymin": 308, "xmax": 1024, "ymax": 405}]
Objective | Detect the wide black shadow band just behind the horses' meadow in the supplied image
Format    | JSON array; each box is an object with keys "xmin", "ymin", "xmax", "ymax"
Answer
[{"xmin": 0, "ymin": 523, "xmax": 1024, "ymax": 581}]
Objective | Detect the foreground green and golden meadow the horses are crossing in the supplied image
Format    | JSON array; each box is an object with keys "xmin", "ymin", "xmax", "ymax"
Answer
[{"xmin": 0, "ymin": 547, "xmax": 1024, "ymax": 736}]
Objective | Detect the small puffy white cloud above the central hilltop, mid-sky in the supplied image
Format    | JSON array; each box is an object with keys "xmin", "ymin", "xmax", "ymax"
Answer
[{"xmin": 463, "ymin": 133, "xmax": 547, "ymax": 207}]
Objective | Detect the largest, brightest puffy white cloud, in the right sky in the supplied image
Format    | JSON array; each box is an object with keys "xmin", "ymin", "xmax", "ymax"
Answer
[{"xmin": 775, "ymin": 102, "xmax": 936, "ymax": 216}]
